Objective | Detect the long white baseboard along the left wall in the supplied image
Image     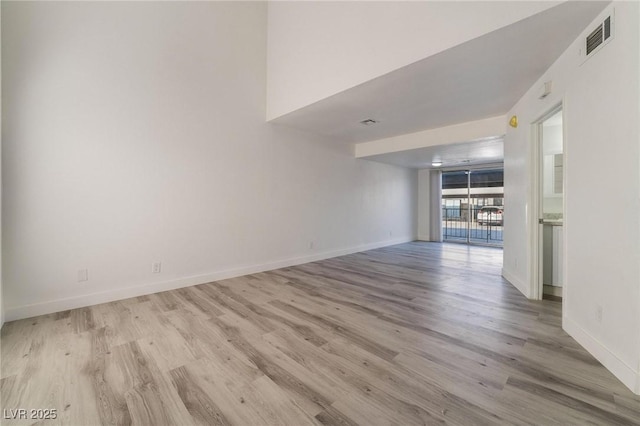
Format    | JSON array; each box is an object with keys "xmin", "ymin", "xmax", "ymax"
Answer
[{"xmin": 4, "ymin": 238, "xmax": 414, "ymax": 322}]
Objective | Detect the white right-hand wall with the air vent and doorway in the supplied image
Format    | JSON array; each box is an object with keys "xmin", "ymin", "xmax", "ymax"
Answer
[{"xmin": 504, "ymin": 2, "xmax": 640, "ymax": 393}]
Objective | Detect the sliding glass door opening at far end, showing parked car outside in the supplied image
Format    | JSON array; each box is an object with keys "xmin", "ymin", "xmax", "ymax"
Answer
[{"xmin": 442, "ymin": 168, "xmax": 505, "ymax": 247}]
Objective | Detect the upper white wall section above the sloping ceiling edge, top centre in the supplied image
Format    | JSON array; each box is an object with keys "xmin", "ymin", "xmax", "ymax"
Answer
[{"xmin": 267, "ymin": 1, "xmax": 560, "ymax": 119}]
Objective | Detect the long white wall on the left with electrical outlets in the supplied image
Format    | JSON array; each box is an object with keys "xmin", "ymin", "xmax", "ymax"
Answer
[{"xmin": 2, "ymin": 2, "xmax": 417, "ymax": 320}]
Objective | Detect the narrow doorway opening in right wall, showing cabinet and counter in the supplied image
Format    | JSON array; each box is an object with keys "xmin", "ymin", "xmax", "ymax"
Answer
[{"xmin": 532, "ymin": 105, "xmax": 565, "ymax": 301}]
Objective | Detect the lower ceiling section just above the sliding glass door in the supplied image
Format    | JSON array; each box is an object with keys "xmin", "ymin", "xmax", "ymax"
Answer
[{"xmin": 363, "ymin": 137, "xmax": 504, "ymax": 169}]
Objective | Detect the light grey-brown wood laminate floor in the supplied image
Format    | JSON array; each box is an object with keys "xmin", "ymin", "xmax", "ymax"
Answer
[{"xmin": 1, "ymin": 242, "xmax": 640, "ymax": 426}]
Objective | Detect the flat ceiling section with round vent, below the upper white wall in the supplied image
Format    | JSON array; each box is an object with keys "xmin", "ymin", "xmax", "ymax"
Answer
[{"xmin": 272, "ymin": 1, "xmax": 609, "ymax": 143}]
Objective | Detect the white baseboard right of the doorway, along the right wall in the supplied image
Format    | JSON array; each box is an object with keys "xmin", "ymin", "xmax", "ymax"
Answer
[{"xmin": 562, "ymin": 316, "xmax": 640, "ymax": 395}]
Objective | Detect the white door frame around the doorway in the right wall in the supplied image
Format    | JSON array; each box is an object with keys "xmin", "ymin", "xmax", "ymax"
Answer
[{"xmin": 528, "ymin": 101, "xmax": 567, "ymax": 306}]
